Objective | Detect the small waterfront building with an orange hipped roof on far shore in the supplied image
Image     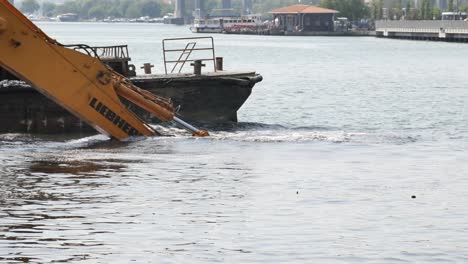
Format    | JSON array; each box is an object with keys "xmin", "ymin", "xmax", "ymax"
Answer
[{"xmin": 269, "ymin": 5, "xmax": 338, "ymax": 32}]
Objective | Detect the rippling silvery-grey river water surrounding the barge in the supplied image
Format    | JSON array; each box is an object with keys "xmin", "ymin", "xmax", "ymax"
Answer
[{"xmin": 0, "ymin": 23, "xmax": 468, "ymax": 263}]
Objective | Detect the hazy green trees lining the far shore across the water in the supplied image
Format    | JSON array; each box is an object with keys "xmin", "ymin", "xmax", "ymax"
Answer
[{"xmin": 20, "ymin": 0, "xmax": 468, "ymax": 21}]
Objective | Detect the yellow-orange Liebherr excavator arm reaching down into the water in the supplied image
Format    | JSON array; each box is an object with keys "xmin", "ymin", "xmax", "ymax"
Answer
[{"xmin": 0, "ymin": 0, "xmax": 208, "ymax": 140}]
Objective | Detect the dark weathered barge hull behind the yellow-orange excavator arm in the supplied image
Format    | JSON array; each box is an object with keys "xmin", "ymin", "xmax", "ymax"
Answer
[{"xmin": 0, "ymin": 72, "xmax": 262, "ymax": 134}]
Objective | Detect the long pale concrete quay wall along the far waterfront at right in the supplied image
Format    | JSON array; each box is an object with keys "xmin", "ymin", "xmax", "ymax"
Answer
[{"xmin": 375, "ymin": 20, "xmax": 468, "ymax": 42}]
